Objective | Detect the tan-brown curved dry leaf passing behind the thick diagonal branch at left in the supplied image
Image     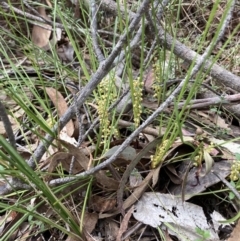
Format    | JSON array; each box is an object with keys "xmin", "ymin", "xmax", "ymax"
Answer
[{"xmin": 45, "ymin": 87, "xmax": 74, "ymax": 137}]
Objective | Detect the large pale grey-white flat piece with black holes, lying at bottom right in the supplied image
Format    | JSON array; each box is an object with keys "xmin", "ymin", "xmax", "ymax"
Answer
[{"xmin": 133, "ymin": 192, "xmax": 229, "ymax": 241}]
